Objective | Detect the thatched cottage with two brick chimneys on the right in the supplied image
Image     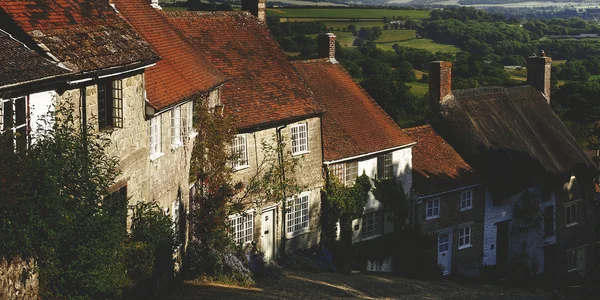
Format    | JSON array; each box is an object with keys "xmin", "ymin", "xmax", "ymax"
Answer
[{"xmin": 429, "ymin": 54, "xmax": 597, "ymax": 284}]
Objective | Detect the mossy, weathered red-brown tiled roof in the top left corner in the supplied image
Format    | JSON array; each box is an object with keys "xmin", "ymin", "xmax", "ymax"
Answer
[{"xmin": 0, "ymin": 0, "xmax": 158, "ymax": 73}]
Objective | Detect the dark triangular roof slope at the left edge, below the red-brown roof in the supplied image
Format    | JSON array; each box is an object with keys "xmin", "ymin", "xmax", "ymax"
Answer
[{"xmin": 0, "ymin": 30, "xmax": 70, "ymax": 88}]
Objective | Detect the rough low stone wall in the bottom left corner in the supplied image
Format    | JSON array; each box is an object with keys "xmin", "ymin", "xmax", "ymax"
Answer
[{"xmin": 0, "ymin": 259, "xmax": 40, "ymax": 300}]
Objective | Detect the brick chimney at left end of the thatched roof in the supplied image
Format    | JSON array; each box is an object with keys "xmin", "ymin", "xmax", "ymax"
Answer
[{"xmin": 429, "ymin": 61, "xmax": 452, "ymax": 109}]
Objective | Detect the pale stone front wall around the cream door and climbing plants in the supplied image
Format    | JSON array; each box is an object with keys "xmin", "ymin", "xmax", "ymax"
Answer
[{"xmin": 232, "ymin": 118, "xmax": 324, "ymax": 255}]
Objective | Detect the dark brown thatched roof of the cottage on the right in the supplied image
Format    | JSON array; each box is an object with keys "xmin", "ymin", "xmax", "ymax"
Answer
[{"xmin": 434, "ymin": 86, "xmax": 594, "ymax": 195}]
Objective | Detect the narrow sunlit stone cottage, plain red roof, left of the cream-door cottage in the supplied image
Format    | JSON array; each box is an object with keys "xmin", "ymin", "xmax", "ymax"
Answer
[{"xmin": 112, "ymin": 0, "xmax": 226, "ymax": 246}]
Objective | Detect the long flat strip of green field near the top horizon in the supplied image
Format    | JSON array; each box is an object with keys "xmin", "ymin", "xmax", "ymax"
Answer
[{"xmin": 267, "ymin": 8, "xmax": 429, "ymax": 19}]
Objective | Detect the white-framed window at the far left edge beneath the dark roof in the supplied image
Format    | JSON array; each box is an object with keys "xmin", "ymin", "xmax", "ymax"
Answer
[{"xmin": 0, "ymin": 97, "xmax": 29, "ymax": 150}]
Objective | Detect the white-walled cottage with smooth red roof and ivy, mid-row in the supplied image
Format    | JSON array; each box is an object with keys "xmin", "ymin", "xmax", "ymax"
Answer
[{"xmin": 294, "ymin": 33, "xmax": 414, "ymax": 271}]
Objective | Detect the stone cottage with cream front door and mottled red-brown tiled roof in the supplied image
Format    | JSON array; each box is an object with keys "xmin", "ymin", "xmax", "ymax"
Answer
[{"xmin": 167, "ymin": 8, "xmax": 323, "ymax": 258}]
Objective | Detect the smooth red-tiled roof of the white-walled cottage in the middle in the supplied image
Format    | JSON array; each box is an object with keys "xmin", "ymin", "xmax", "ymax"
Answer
[{"xmin": 294, "ymin": 59, "xmax": 413, "ymax": 161}]
